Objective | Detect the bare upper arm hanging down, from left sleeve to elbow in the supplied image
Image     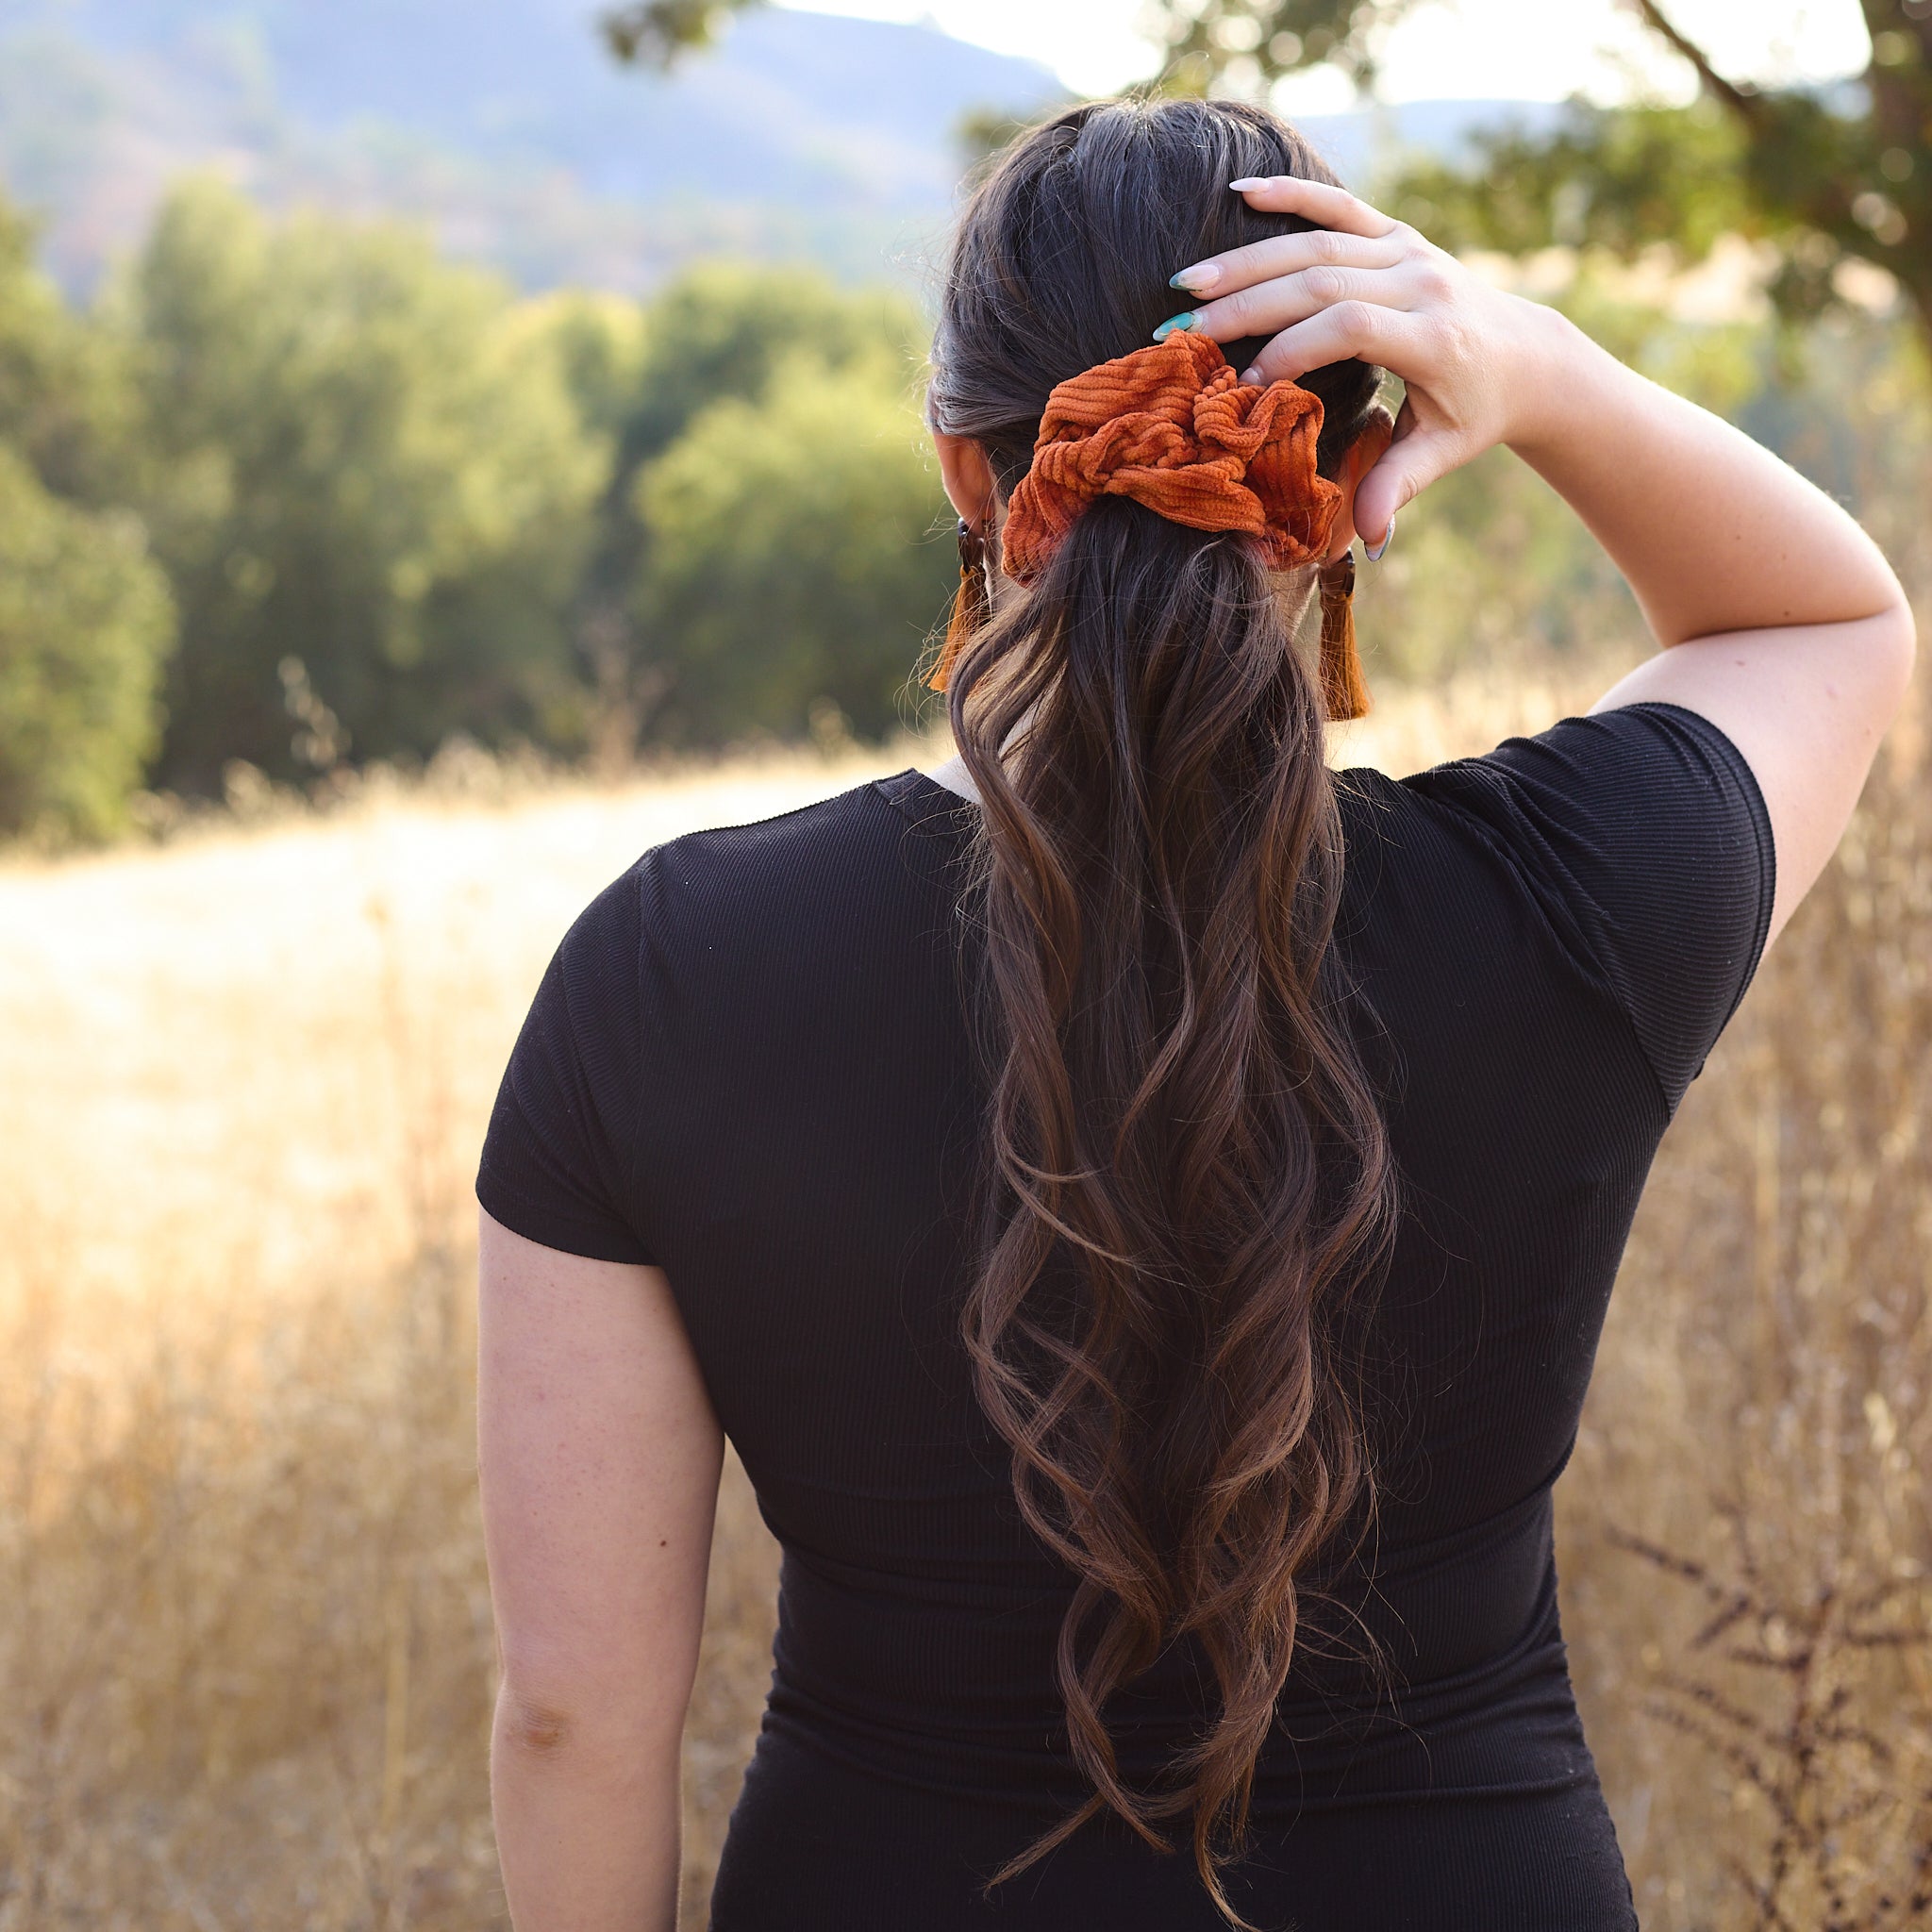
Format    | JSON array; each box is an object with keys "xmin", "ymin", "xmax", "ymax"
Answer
[{"xmin": 477, "ymin": 1213, "xmax": 724, "ymax": 1748}]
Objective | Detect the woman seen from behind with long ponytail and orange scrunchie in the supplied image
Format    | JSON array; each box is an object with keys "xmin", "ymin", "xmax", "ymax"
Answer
[{"xmin": 479, "ymin": 103, "xmax": 1913, "ymax": 1932}]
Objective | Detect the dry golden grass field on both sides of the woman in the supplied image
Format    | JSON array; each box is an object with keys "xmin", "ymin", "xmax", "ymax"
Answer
[{"xmin": 0, "ymin": 682, "xmax": 1932, "ymax": 1932}]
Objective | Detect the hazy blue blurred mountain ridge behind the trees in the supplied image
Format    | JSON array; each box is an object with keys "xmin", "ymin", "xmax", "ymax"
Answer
[{"xmin": 0, "ymin": 0, "xmax": 1549, "ymax": 291}]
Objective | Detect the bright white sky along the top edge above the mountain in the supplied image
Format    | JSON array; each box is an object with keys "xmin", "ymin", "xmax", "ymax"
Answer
[{"xmin": 769, "ymin": 0, "xmax": 1868, "ymax": 114}]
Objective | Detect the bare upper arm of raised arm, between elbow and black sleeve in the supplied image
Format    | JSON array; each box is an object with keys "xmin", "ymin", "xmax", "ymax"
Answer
[{"xmin": 1592, "ymin": 603, "xmax": 1915, "ymax": 942}]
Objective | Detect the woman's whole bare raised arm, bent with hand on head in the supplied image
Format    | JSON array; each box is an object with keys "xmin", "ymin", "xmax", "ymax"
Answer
[{"xmin": 1174, "ymin": 175, "xmax": 1915, "ymax": 933}]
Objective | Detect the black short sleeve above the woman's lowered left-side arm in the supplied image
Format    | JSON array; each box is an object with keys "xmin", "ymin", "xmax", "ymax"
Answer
[{"xmin": 477, "ymin": 872, "xmax": 653, "ymax": 1261}]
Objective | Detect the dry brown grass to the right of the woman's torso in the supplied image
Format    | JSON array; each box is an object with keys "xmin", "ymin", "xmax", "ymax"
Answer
[{"xmin": 1557, "ymin": 683, "xmax": 1932, "ymax": 1932}]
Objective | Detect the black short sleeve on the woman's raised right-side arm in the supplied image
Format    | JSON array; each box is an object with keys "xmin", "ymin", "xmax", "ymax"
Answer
[{"xmin": 1405, "ymin": 703, "xmax": 1775, "ymax": 1109}]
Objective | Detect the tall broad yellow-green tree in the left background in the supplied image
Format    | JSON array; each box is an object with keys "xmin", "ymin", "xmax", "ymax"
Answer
[{"xmin": 120, "ymin": 182, "xmax": 607, "ymax": 791}]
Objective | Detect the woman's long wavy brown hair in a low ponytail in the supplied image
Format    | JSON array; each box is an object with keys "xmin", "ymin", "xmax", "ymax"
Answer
[{"xmin": 929, "ymin": 100, "xmax": 1393, "ymax": 1919}]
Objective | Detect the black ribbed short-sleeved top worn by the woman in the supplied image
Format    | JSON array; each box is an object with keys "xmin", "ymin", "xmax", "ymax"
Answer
[{"xmin": 477, "ymin": 706, "xmax": 1774, "ymax": 1932}]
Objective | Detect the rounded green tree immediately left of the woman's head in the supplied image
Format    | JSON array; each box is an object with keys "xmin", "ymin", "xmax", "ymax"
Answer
[{"xmin": 634, "ymin": 348, "xmax": 958, "ymax": 743}]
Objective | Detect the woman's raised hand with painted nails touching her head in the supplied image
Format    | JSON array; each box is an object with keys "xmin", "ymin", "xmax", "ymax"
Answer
[{"xmin": 1163, "ymin": 175, "xmax": 1586, "ymax": 535}]
